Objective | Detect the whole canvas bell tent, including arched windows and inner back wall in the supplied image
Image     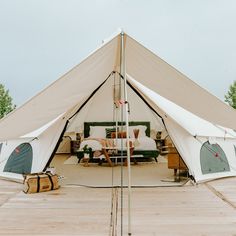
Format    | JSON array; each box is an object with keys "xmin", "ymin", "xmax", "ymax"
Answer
[{"xmin": 0, "ymin": 32, "xmax": 236, "ymax": 182}]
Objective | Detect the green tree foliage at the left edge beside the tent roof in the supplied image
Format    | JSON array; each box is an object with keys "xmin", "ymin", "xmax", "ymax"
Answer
[{"xmin": 0, "ymin": 84, "xmax": 16, "ymax": 119}]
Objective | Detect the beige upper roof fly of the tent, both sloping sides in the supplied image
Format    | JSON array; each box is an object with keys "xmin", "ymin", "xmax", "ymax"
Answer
[{"xmin": 0, "ymin": 30, "xmax": 236, "ymax": 141}]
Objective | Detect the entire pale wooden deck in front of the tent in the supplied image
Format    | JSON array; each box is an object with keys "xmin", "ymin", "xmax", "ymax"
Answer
[{"xmin": 0, "ymin": 178, "xmax": 236, "ymax": 236}]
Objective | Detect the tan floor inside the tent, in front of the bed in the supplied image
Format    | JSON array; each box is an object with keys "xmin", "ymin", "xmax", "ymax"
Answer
[{"xmin": 50, "ymin": 154, "xmax": 188, "ymax": 187}]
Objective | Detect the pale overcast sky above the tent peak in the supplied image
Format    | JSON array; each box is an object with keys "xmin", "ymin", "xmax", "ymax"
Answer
[{"xmin": 0, "ymin": 0, "xmax": 236, "ymax": 105}]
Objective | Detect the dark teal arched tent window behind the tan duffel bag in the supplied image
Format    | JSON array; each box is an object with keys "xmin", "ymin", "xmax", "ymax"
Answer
[{"xmin": 3, "ymin": 143, "xmax": 33, "ymax": 174}]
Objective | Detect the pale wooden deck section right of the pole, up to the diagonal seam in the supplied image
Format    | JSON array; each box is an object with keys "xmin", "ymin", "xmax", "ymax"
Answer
[{"xmin": 118, "ymin": 184, "xmax": 236, "ymax": 235}]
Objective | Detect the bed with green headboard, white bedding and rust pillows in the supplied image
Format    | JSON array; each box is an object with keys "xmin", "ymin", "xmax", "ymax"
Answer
[{"xmin": 80, "ymin": 121, "xmax": 159, "ymax": 161}]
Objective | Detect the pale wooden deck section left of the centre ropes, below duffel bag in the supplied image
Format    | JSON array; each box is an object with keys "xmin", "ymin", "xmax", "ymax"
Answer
[{"xmin": 0, "ymin": 181, "xmax": 110, "ymax": 235}]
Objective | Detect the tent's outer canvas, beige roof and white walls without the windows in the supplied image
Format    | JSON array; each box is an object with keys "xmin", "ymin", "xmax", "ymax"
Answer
[{"xmin": 0, "ymin": 32, "xmax": 236, "ymax": 181}]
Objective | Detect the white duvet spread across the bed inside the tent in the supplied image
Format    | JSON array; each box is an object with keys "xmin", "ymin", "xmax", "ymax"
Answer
[{"xmin": 80, "ymin": 136, "xmax": 156, "ymax": 151}]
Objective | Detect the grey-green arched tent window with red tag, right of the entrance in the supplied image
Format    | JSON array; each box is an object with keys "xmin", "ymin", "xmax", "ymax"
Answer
[{"xmin": 200, "ymin": 141, "xmax": 230, "ymax": 174}]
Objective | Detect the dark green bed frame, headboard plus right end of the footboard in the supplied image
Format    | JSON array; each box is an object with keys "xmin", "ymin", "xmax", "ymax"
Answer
[{"xmin": 84, "ymin": 121, "xmax": 160, "ymax": 161}]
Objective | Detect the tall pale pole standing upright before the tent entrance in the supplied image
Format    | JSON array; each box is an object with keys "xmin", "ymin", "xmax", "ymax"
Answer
[{"xmin": 120, "ymin": 31, "xmax": 131, "ymax": 235}]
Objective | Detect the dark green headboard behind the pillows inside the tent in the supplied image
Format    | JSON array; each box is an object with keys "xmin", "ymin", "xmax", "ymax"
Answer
[{"xmin": 84, "ymin": 121, "xmax": 150, "ymax": 138}]
